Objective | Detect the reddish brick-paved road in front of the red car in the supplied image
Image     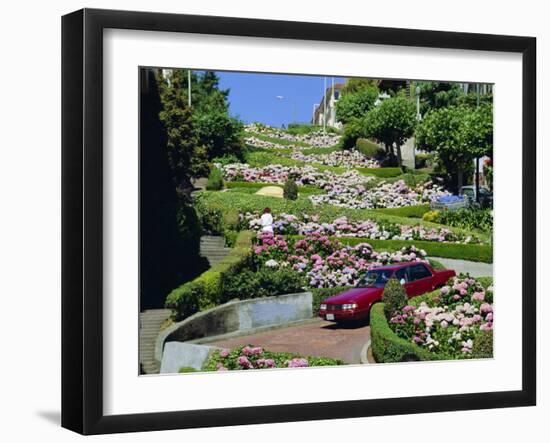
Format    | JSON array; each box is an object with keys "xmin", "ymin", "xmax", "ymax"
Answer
[{"xmin": 209, "ymin": 319, "xmax": 370, "ymax": 363}]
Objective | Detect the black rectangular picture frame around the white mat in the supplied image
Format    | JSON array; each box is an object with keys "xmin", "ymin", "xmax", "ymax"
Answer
[{"xmin": 62, "ymin": 9, "xmax": 536, "ymax": 434}]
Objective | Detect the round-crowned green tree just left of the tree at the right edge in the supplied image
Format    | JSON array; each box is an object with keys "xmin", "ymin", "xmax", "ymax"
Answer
[{"xmin": 363, "ymin": 95, "xmax": 416, "ymax": 167}]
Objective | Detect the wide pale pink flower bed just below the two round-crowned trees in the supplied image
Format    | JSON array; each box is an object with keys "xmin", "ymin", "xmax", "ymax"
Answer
[{"xmin": 309, "ymin": 180, "xmax": 449, "ymax": 209}]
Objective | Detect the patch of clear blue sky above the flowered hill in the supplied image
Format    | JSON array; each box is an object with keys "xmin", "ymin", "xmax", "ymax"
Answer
[{"xmin": 216, "ymin": 72, "xmax": 343, "ymax": 127}]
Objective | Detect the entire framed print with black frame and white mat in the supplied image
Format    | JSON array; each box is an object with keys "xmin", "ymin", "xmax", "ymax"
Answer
[{"xmin": 62, "ymin": 9, "xmax": 536, "ymax": 434}]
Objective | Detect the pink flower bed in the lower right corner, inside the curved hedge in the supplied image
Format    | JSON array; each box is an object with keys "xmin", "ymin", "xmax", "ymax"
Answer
[{"xmin": 389, "ymin": 276, "xmax": 493, "ymax": 358}]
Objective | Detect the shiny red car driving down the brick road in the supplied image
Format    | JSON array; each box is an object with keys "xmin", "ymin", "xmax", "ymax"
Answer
[{"xmin": 319, "ymin": 261, "xmax": 456, "ymax": 321}]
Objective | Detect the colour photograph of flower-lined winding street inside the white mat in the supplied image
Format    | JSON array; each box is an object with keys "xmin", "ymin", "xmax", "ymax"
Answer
[{"xmin": 139, "ymin": 66, "xmax": 495, "ymax": 376}]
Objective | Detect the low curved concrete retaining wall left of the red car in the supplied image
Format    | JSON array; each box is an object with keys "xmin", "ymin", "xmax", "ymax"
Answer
[{"xmin": 155, "ymin": 292, "xmax": 313, "ymax": 363}]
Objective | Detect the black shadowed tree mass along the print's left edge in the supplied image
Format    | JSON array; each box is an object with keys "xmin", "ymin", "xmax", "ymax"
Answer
[{"xmin": 139, "ymin": 68, "xmax": 208, "ymax": 309}]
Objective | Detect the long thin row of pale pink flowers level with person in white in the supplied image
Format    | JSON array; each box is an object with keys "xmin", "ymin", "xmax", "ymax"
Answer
[{"xmin": 239, "ymin": 212, "xmax": 481, "ymax": 243}]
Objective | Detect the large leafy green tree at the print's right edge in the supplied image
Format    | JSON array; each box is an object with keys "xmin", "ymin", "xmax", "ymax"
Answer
[{"xmin": 416, "ymin": 105, "xmax": 493, "ymax": 190}]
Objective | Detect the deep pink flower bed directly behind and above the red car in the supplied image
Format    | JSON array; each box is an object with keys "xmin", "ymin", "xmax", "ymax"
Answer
[{"xmin": 253, "ymin": 232, "xmax": 426, "ymax": 288}]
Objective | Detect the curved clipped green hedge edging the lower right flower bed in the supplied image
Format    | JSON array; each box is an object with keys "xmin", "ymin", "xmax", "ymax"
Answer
[{"xmin": 370, "ymin": 303, "xmax": 451, "ymax": 363}]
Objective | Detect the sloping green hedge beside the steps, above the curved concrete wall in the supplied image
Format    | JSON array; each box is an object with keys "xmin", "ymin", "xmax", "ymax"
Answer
[{"xmin": 166, "ymin": 231, "xmax": 254, "ymax": 320}]
